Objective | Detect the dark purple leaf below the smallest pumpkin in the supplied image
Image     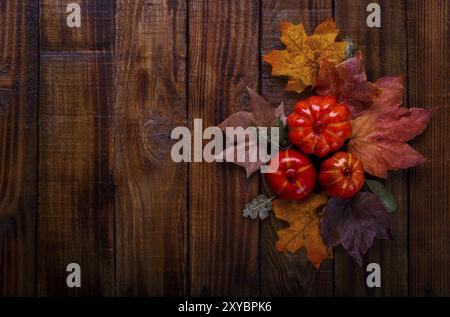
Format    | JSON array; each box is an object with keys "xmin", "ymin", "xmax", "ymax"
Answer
[{"xmin": 320, "ymin": 192, "xmax": 391, "ymax": 266}]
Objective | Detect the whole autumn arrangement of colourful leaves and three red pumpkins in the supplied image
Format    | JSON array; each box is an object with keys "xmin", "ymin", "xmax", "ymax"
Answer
[{"xmin": 219, "ymin": 19, "xmax": 435, "ymax": 268}]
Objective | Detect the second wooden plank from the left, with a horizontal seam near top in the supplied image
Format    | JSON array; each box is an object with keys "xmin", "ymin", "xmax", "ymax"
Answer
[{"xmin": 37, "ymin": 0, "xmax": 115, "ymax": 296}]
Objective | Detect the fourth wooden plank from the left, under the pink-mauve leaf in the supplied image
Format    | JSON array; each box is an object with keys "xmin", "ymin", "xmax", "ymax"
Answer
[{"xmin": 188, "ymin": 0, "xmax": 260, "ymax": 296}]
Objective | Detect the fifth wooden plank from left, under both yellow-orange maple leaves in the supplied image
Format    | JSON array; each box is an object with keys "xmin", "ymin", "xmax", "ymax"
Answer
[{"xmin": 261, "ymin": 0, "xmax": 333, "ymax": 296}]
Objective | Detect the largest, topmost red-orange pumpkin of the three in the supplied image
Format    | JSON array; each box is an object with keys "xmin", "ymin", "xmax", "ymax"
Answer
[{"xmin": 287, "ymin": 96, "xmax": 352, "ymax": 157}]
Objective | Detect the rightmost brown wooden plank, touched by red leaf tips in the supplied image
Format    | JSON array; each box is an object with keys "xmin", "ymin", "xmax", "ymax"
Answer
[{"xmin": 407, "ymin": 0, "xmax": 450, "ymax": 296}]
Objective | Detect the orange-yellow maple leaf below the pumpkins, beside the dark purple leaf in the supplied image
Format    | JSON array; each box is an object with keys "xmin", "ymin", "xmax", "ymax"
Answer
[{"xmin": 272, "ymin": 194, "xmax": 333, "ymax": 268}]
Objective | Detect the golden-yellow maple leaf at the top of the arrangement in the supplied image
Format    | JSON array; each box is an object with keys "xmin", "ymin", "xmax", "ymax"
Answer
[{"xmin": 263, "ymin": 18, "xmax": 348, "ymax": 93}]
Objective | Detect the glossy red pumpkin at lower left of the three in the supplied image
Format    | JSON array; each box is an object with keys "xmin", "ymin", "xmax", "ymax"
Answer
[{"xmin": 265, "ymin": 149, "xmax": 317, "ymax": 200}]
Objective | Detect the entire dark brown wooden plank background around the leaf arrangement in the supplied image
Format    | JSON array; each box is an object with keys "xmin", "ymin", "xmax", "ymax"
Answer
[{"xmin": 0, "ymin": 0, "xmax": 450, "ymax": 296}]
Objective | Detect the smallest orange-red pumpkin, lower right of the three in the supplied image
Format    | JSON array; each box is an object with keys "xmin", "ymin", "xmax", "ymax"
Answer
[{"xmin": 319, "ymin": 152, "xmax": 364, "ymax": 198}]
